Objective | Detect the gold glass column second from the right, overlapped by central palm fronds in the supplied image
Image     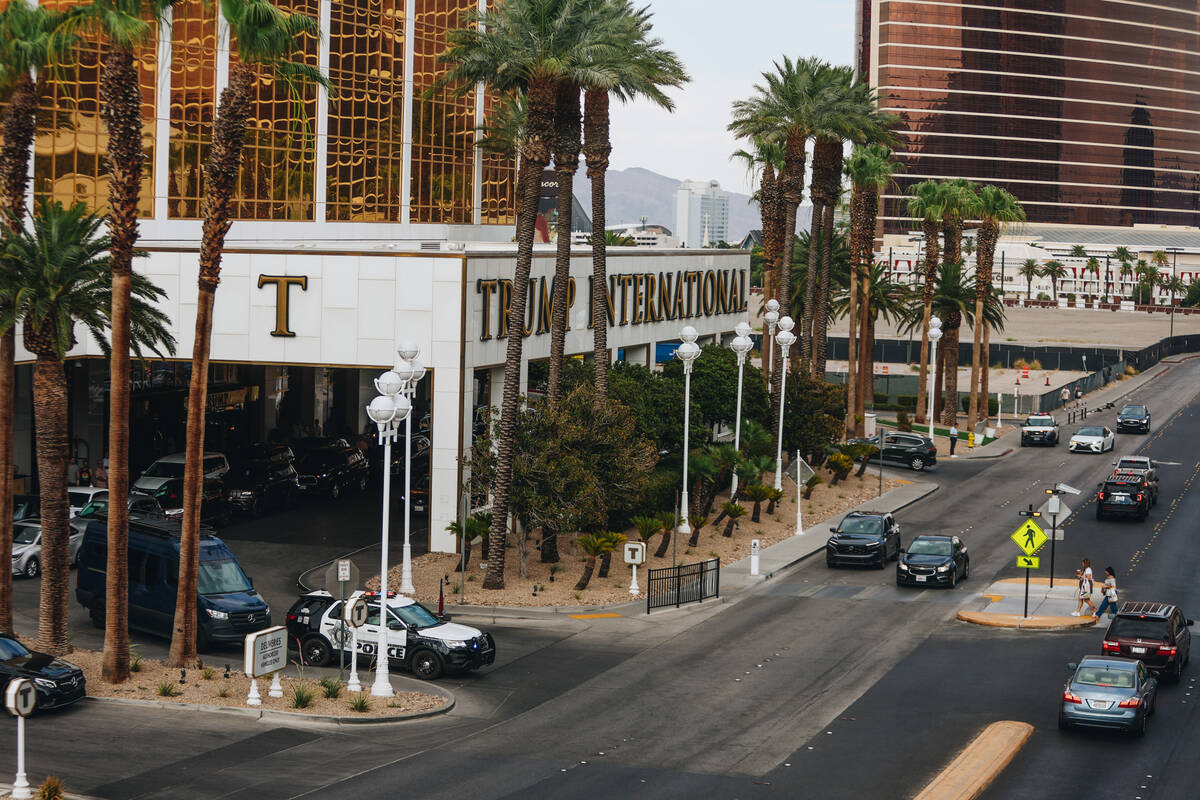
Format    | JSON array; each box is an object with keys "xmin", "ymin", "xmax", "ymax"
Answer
[{"xmin": 410, "ymin": 0, "xmax": 479, "ymax": 224}]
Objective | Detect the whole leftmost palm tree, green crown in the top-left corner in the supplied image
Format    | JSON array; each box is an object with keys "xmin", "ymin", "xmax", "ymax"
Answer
[{"xmin": 0, "ymin": 0, "xmax": 73, "ymax": 631}]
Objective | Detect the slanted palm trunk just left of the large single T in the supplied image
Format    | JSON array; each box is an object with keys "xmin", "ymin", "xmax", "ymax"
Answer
[{"xmin": 167, "ymin": 64, "xmax": 254, "ymax": 667}]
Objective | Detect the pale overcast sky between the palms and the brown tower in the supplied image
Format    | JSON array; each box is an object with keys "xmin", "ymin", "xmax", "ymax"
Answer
[{"xmin": 612, "ymin": 0, "xmax": 854, "ymax": 194}]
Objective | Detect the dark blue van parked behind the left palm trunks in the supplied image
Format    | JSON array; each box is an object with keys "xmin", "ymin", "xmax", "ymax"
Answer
[{"xmin": 76, "ymin": 518, "xmax": 271, "ymax": 652}]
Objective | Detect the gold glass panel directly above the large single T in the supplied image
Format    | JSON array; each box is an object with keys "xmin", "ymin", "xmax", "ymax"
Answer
[{"xmin": 229, "ymin": 0, "xmax": 320, "ymax": 219}]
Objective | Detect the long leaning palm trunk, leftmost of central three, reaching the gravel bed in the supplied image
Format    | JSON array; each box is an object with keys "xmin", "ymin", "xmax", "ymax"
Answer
[{"xmin": 484, "ymin": 80, "xmax": 556, "ymax": 589}]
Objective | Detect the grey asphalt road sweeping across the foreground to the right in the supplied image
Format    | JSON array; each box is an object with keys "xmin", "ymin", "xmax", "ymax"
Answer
[{"xmin": 9, "ymin": 362, "xmax": 1200, "ymax": 800}]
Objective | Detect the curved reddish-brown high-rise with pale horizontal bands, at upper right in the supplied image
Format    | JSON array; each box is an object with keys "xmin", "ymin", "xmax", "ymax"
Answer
[{"xmin": 857, "ymin": 0, "xmax": 1200, "ymax": 233}]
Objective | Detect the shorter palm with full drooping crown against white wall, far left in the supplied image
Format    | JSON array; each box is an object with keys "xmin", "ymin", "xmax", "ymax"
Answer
[{"xmin": 0, "ymin": 200, "xmax": 175, "ymax": 655}]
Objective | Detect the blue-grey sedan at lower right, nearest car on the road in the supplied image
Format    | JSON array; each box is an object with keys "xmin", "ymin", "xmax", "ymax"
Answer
[{"xmin": 1058, "ymin": 656, "xmax": 1158, "ymax": 736}]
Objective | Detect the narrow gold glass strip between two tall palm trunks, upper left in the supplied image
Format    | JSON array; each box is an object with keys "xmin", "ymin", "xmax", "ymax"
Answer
[{"xmin": 167, "ymin": 0, "xmax": 217, "ymax": 218}]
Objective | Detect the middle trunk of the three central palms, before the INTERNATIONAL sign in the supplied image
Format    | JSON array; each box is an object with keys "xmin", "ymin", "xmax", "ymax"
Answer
[{"xmin": 546, "ymin": 83, "xmax": 580, "ymax": 407}]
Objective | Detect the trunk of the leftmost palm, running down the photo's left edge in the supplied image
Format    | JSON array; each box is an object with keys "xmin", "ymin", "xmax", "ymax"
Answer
[{"xmin": 0, "ymin": 73, "xmax": 37, "ymax": 631}]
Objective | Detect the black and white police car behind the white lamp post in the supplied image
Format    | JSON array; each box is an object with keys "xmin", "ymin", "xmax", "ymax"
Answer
[{"xmin": 287, "ymin": 591, "xmax": 496, "ymax": 680}]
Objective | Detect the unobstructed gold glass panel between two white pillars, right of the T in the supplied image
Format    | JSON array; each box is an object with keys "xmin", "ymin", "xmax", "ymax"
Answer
[{"xmin": 325, "ymin": 0, "xmax": 404, "ymax": 222}]
